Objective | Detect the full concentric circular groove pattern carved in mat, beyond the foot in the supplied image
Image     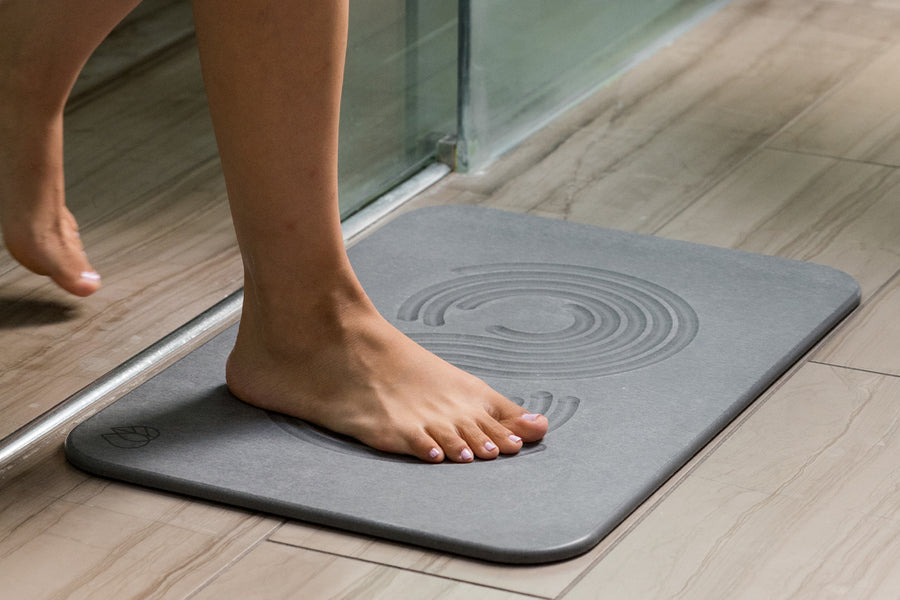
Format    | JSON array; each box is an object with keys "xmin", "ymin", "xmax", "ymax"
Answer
[{"xmin": 397, "ymin": 263, "xmax": 699, "ymax": 379}]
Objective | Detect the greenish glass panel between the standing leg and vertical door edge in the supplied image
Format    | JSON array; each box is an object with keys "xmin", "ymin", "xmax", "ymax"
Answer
[{"xmin": 339, "ymin": 0, "xmax": 458, "ymax": 217}]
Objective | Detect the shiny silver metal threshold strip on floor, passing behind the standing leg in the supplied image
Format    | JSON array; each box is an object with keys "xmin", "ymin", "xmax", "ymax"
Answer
[{"xmin": 0, "ymin": 163, "xmax": 450, "ymax": 474}]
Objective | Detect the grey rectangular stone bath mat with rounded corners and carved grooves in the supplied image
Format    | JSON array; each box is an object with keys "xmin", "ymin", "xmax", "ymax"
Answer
[{"xmin": 66, "ymin": 207, "xmax": 859, "ymax": 563}]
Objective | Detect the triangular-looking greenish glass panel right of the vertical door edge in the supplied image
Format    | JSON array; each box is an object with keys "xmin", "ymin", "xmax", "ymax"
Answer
[{"xmin": 456, "ymin": 0, "xmax": 727, "ymax": 171}]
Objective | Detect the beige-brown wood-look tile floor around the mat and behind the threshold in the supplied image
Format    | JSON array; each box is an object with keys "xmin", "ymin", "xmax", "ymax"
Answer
[{"xmin": 0, "ymin": 0, "xmax": 900, "ymax": 600}]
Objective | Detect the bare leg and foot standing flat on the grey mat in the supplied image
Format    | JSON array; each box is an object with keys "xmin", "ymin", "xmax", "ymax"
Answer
[{"xmin": 194, "ymin": 0, "xmax": 547, "ymax": 462}]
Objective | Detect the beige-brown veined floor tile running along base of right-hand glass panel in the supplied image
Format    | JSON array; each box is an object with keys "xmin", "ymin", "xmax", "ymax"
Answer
[{"xmin": 464, "ymin": 3, "xmax": 884, "ymax": 232}]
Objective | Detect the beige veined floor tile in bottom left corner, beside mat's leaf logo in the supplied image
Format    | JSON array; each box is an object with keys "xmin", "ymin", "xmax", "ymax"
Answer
[{"xmin": 0, "ymin": 446, "xmax": 281, "ymax": 600}]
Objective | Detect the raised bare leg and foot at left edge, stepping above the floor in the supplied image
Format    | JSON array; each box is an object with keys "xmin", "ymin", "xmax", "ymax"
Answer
[{"xmin": 0, "ymin": 0, "xmax": 140, "ymax": 296}]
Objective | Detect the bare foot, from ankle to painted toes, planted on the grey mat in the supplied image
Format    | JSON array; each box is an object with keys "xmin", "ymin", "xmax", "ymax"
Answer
[{"xmin": 226, "ymin": 284, "xmax": 548, "ymax": 462}]
